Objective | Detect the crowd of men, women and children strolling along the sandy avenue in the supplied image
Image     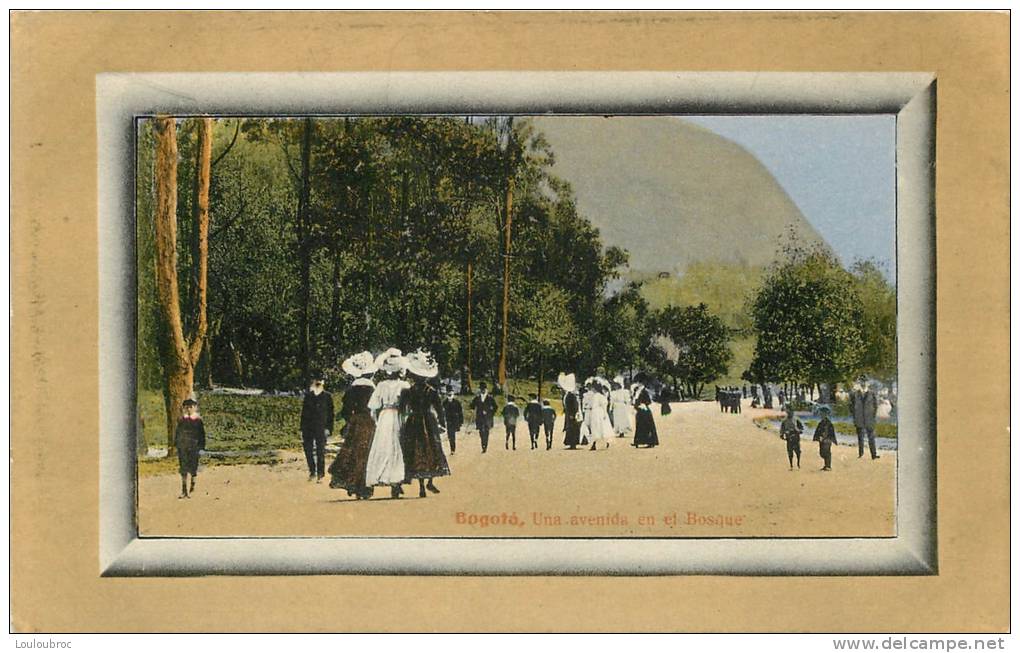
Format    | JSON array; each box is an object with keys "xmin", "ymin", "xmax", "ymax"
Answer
[{"xmin": 167, "ymin": 357, "xmax": 879, "ymax": 500}]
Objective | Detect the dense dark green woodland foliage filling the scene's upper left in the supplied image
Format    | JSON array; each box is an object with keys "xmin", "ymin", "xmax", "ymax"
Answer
[{"xmin": 138, "ymin": 116, "xmax": 644, "ymax": 389}]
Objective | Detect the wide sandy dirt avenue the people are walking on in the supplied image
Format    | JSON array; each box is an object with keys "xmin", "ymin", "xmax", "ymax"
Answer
[{"xmin": 139, "ymin": 402, "xmax": 897, "ymax": 537}]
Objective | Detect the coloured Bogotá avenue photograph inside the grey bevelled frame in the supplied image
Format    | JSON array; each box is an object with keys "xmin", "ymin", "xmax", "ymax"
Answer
[{"xmin": 135, "ymin": 114, "xmax": 901, "ymax": 539}]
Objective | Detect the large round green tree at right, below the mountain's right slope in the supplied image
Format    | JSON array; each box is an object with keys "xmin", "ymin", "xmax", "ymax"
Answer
[{"xmin": 751, "ymin": 241, "xmax": 864, "ymax": 385}]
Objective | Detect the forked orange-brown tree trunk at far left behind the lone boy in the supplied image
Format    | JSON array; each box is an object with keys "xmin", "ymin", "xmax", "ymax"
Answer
[{"xmin": 153, "ymin": 116, "xmax": 212, "ymax": 455}]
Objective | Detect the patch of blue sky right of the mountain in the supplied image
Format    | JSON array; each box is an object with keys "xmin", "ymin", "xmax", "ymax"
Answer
[{"xmin": 681, "ymin": 114, "xmax": 896, "ymax": 281}]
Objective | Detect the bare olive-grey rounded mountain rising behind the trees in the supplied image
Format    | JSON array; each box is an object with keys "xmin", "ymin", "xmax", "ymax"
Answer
[{"xmin": 532, "ymin": 116, "xmax": 822, "ymax": 271}]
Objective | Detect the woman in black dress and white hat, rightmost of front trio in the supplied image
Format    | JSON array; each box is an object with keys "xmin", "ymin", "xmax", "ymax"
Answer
[{"xmin": 400, "ymin": 349, "xmax": 450, "ymax": 498}]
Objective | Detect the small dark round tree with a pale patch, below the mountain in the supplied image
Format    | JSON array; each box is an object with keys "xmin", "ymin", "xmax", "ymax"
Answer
[{"xmin": 653, "ymin": 304, "xmax": 733, "ymax": 397}]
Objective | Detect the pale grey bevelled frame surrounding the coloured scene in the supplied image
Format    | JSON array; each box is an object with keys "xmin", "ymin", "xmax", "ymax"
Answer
[{"xmin": 96, "ymin": 72, "xmax": 937, "ymax": 575}]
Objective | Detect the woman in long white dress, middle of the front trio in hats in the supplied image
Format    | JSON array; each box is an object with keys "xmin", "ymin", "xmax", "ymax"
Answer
[{"xmin": 365, "ymin": 349, "xmax": 410, "ymax": 499}]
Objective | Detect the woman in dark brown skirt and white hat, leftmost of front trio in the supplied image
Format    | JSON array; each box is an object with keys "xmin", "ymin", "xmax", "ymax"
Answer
[{"xmin": 329, "ymin": 351, "xmax": 376, "ymax": 500}]
